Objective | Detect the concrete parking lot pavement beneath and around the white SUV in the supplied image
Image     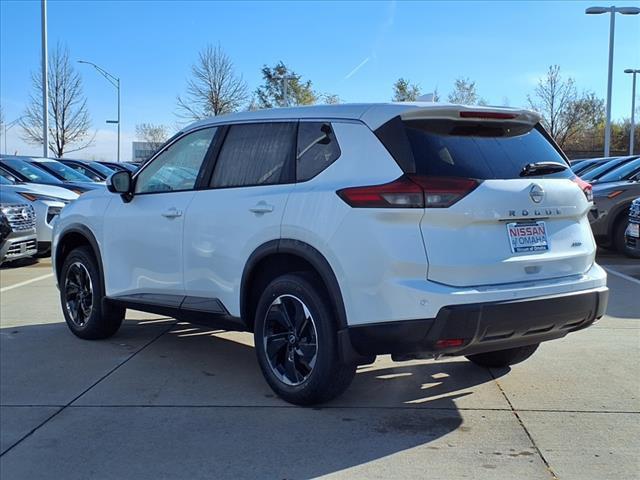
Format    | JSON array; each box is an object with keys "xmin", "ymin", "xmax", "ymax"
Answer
[{"xmin": 0, "ymin": 254, "xmax": 640, "ymax": 480}]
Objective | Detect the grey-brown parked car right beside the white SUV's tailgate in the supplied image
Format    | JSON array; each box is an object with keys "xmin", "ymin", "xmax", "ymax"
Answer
[{"xmin": 589, "ymin": 158, "xmax": 640, "ymax": 253}]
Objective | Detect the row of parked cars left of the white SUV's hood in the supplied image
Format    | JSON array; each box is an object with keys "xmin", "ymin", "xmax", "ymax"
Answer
[{"xmin": 0, "ymin": 155, "xmax": 136, "ymax": 264}]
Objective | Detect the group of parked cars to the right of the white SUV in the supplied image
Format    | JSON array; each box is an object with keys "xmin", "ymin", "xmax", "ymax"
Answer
[{"xmin": 571, "ymin": 155, "xmax": 640, "ymax": 257}]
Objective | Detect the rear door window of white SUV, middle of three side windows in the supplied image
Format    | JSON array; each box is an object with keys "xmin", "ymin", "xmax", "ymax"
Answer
[{"xmin": 211, "ymin": 122, "xmax": 296, "ymax": 187}]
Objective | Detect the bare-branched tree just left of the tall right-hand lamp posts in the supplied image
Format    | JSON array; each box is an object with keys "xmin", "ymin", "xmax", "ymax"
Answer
[{"xmin": 527, "ymin": 65, "xmax": 604, "ymax": 147}]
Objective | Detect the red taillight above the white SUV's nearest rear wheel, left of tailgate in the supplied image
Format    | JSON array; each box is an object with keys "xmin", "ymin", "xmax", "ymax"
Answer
[{"xmin": 336, "ymin": 175, "xmax": 479, "ymax": 208}]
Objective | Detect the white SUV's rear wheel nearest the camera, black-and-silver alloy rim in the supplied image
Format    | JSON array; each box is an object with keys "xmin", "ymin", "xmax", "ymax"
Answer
[{"xmin": 254, "ymin": 273, "xmax": 356, "ymax": 405}]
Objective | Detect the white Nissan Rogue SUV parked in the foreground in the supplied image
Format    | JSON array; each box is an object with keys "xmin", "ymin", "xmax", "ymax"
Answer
[{"xmin": 53, "ymin": 104, "xmax": 608, "ymax": 404}]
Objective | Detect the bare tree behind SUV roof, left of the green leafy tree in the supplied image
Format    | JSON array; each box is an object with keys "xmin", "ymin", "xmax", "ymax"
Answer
[{"xmin": 177, "ymin": 45, "xmax": 249, "ymax": 120}]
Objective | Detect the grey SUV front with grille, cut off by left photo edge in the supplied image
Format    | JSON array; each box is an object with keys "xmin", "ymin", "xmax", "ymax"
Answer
[{"xmin": 0, "ymin": 188, "xmax": 38, "ymax": 265}]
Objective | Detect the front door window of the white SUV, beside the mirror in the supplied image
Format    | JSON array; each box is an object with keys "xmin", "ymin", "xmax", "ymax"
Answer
[{"xmin": 135, "ymin": 127, "xmax": 216, "ymax": 193}]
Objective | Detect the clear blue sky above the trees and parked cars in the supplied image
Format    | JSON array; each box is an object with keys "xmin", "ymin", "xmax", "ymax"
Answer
[{"xmin": 0, "ymin": 0, "xmax": 640, "ymax": 159}]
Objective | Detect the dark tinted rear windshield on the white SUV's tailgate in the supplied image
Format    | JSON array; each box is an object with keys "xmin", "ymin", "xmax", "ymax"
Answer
[{"xmin": 376, "ymin": 117, "xmax": 573, "ymax": 180}]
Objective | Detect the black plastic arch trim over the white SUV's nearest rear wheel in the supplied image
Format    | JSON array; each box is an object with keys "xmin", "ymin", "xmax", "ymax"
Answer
[{"xmin": 240, "ymin": 239, "xmax": 347, "ymax": 330}]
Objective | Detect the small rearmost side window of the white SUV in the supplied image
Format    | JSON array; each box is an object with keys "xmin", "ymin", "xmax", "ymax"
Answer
[{"xmin": 296, "ymin": 122, "xmax": 340, "ymax": 182}]
